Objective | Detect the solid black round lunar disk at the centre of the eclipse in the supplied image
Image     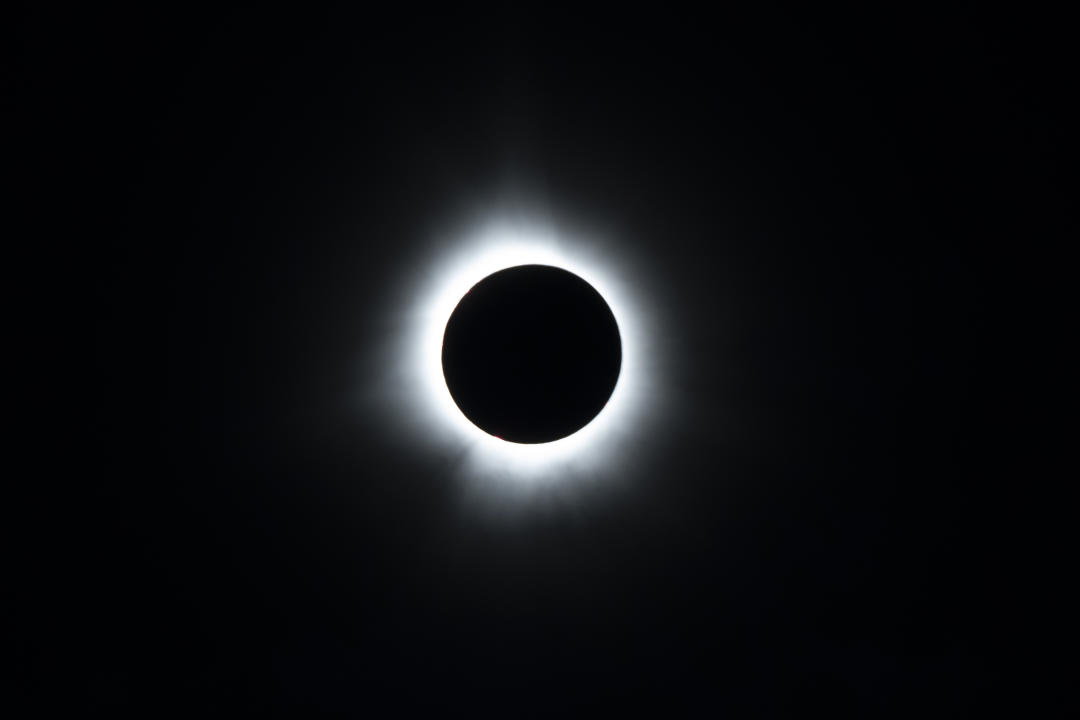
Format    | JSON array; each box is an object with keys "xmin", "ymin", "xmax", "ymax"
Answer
[{"xmin": 443, "ymin": 264, "xmax": 622, "ymax": 443}]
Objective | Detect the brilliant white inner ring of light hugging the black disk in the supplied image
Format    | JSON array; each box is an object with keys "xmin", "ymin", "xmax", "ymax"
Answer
[{"xmin": 410, "ymin": 213, "xmax": 646, "ymax": 479}]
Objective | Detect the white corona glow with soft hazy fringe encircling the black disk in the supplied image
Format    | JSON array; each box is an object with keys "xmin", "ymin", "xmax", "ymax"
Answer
[{"xmin": 386, "ymin": 211, "xmax": 657, "ymax": 498}]
